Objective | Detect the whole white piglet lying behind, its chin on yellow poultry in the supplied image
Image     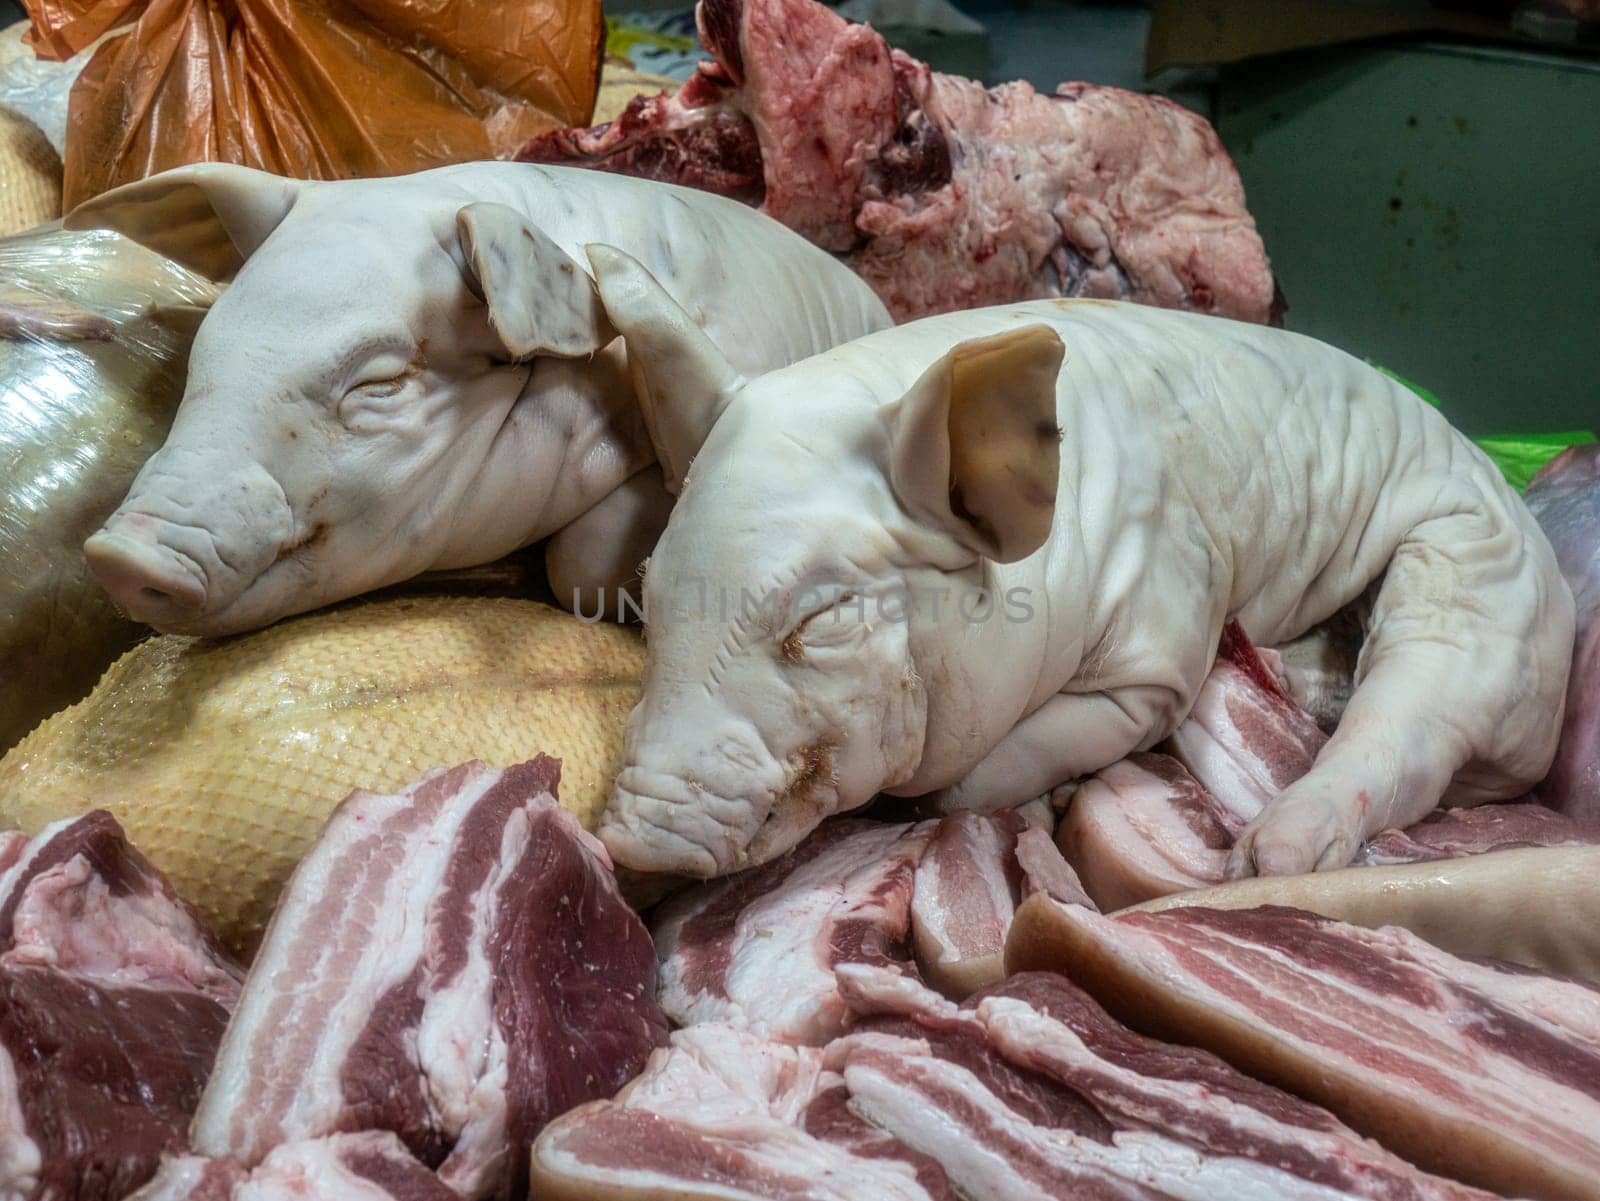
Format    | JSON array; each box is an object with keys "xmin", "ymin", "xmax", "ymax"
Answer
[{"xmin": 67, "ymin": 163, "xmax": 888, "ymax": 635}]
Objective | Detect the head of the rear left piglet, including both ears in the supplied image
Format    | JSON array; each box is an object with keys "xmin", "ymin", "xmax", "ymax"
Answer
[{"xmin": 69, "ymin": 163, "xmax": 614, "ymax": 635}]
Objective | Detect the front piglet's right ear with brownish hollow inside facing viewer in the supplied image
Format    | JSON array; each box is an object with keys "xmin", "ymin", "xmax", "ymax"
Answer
[{"xmin": 880, "ymin": 325, "xmax": 1064, "ymax": 563}]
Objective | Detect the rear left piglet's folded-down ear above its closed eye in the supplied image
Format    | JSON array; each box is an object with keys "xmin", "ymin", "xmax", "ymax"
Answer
[{"xmin": 456, "ymin": 203, "xmax": 616, "ymax": 360}]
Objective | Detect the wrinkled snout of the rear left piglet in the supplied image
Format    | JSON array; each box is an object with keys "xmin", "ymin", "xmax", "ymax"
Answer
[{"xmin": 83, "ymin": 459, "xmax": 294, "ymax": 635}]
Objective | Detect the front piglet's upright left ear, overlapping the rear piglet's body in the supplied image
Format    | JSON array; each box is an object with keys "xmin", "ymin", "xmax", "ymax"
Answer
[{"xmin": 584, "ymin": 245, "xmax": 744, "ymax": 496}]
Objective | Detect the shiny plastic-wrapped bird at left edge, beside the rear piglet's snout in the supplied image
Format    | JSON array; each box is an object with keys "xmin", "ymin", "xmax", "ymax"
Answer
[{"xmin": 0, "ymin": 229, "xmax": 219, "ymax": 750}]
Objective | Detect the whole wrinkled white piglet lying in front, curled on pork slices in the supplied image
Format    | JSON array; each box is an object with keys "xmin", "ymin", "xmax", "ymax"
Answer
[{"xmin": 589, "ymin": 248, "xmax": 1573, "ymax": 875}]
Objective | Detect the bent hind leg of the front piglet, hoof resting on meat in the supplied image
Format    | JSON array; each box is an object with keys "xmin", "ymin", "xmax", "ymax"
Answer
[{"xmin": 1229, "ymin": 512, "xmax": 1573, "ymax": 876}]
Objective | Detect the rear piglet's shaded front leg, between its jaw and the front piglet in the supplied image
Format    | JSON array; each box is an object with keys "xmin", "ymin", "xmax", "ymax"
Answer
[{"xmin": 544, "ymin": 467, "xmax": 672, "ymax": 620}]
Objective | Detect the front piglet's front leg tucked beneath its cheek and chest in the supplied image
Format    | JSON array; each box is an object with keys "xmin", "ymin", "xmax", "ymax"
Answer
[{"xmin": 933, "ymin": 684, "xmax": 1182, "ymax": 812}]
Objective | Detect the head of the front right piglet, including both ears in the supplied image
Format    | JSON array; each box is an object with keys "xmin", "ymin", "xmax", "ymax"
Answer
[{"xmin": 589, "ymin": 246, "xmax": 1062, "ymax": 876}]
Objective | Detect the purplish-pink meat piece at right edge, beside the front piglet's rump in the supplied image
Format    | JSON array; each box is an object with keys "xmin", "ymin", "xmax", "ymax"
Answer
[{"xmin": 1528, "ymin": 445, "xmax": 1600, "ymax": 822}]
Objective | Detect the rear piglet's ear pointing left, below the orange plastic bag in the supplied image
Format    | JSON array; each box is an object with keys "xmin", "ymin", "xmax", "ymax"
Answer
[{"xmin": 62, "ymin": 163, "xmax": 307, "ymax": 280}]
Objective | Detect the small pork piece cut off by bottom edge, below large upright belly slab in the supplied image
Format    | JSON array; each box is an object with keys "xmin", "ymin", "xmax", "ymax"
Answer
[{"xmin": 136, "ymin": 1131, "xmax": 461, "ymax": 1201}]
